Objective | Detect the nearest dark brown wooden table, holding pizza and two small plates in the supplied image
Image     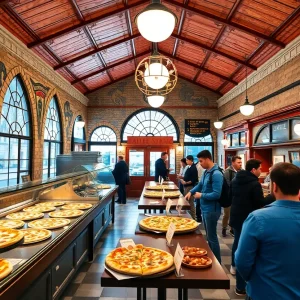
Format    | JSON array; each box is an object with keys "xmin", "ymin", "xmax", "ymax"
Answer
[{"xmin": 101, "ymin": 233, "xmax": 230, "ymax": 300}]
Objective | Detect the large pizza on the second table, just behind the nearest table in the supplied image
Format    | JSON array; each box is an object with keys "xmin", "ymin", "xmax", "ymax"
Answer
[{"xmin": 139, "ymin": 216, "xmax": 199, "ymax": 232}]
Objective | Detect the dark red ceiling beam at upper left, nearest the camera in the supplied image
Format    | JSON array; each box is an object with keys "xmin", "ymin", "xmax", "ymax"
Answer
[{"xmin": 27, "ymin": 0, "xmax": 145, "ymax": 48}]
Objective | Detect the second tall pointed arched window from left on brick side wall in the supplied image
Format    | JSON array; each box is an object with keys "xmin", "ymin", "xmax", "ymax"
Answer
[{"xmin": 43, "ymin": 97, "xmax": 62, "ymax": 179}]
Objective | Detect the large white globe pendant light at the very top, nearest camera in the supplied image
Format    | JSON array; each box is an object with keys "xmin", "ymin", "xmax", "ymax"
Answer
[{"xmin": 134, "ymin": 0, "xmax": 178, "ymax": 43}]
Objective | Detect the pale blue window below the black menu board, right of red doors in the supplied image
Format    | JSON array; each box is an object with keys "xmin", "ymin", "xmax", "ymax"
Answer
[{"xmin": 184, "ymin": 134, "xmax": 214, "ymax": 162}]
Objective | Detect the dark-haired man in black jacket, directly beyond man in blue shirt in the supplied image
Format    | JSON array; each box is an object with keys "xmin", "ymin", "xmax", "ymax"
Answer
[{"xmin": 229, "ymin": 159, "xmax": 264, "ymax": 295}]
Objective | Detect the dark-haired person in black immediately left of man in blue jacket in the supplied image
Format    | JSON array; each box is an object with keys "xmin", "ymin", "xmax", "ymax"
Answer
[{"xmin": 180, "ymin": 155, "xmax": 198, "ymax": 220}]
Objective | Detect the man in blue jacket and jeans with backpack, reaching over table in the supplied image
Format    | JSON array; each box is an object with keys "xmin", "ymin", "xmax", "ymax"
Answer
[{"xmin": 185, "ymin": 150, "xmax": 223, "ymax": 263}]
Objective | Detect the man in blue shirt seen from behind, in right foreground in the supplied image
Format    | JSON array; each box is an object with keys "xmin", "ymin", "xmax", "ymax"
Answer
[{"xmin": 235, "ymin": 163, "xmax": 300, "ymax": 300}]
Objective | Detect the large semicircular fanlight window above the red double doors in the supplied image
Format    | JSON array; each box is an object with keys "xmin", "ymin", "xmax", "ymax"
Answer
[{"xmin": 121, "ymin": 109, "xmax": 179, "ymax": 142}]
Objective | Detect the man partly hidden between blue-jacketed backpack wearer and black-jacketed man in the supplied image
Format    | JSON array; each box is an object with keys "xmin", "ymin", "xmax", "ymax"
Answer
[{"xmin": 222, "ymin": 155, "xmax": 242, "ymax": 237}]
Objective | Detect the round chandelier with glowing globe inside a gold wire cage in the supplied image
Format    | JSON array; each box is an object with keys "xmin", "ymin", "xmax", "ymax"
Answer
[{"xmin": 135, "ymin": 45, "xmax": 178, "ymax": 101}]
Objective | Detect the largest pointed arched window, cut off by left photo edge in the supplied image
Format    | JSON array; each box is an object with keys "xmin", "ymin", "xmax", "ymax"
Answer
[{"xmin": 0, "ymin": 76, "xmax": 32, "ymax": 187}]
